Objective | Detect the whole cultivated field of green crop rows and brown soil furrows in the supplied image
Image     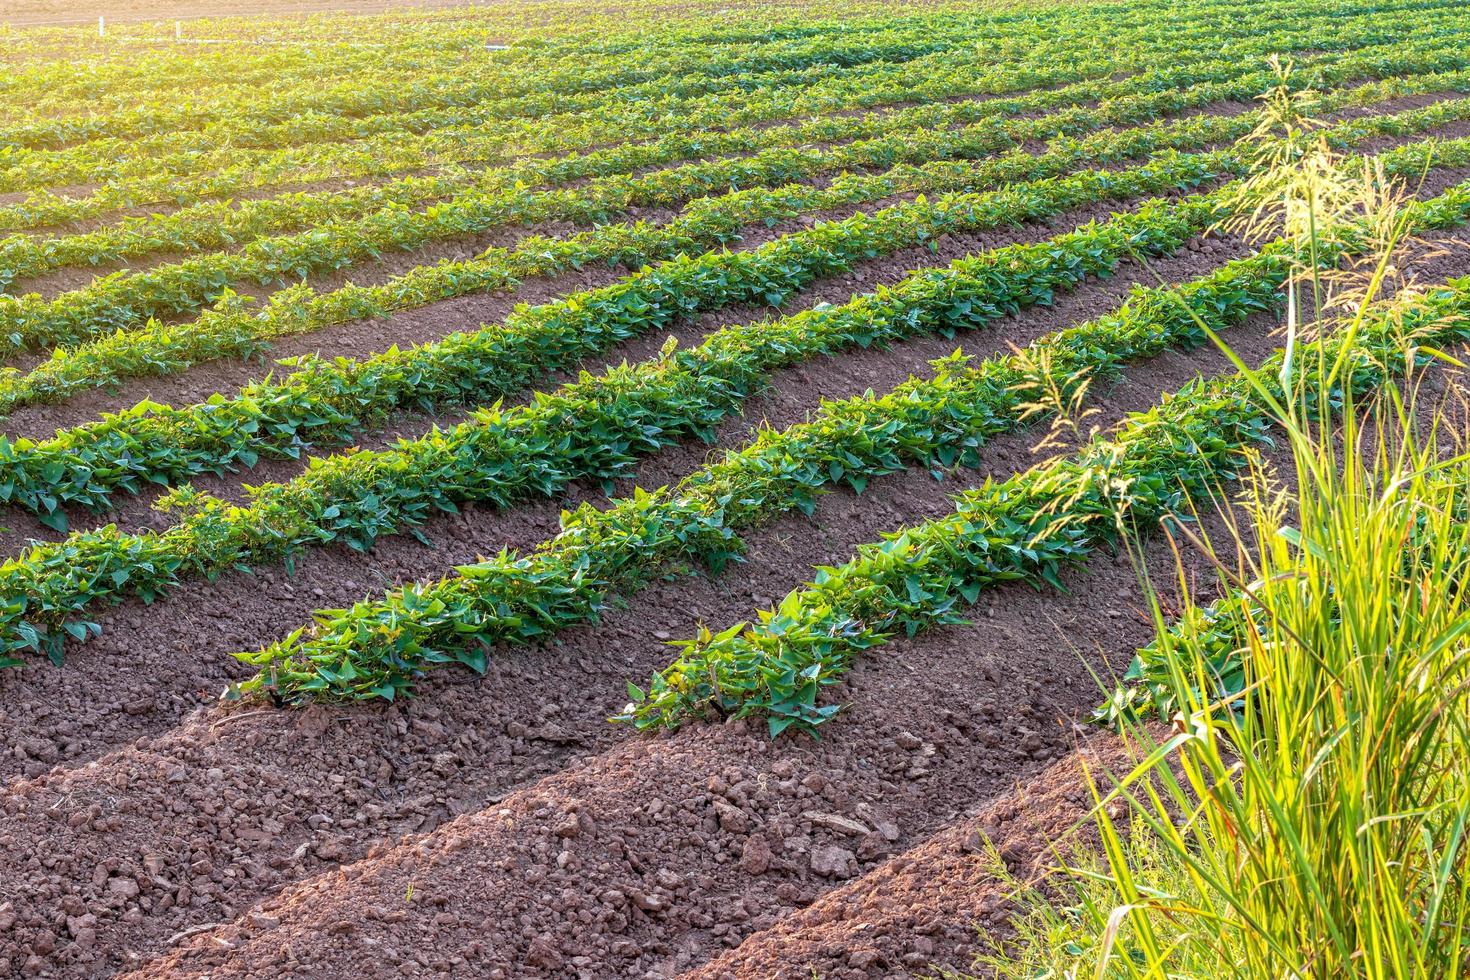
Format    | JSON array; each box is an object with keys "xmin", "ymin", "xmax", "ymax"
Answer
[{"xmin": 0, "ymin": 0, "xmax": 1470, "ymax": 980}]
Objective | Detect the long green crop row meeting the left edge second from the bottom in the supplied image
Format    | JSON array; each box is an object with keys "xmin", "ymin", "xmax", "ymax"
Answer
[{"xmin": 0, "ymin": 88, "xmax": 1470, "ymax": 527}]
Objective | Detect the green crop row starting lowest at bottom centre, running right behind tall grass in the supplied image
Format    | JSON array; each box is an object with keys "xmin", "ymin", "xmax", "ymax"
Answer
[{"xmin": 619, "ymin": 270, "xmax": 1470, "ymax": 733}]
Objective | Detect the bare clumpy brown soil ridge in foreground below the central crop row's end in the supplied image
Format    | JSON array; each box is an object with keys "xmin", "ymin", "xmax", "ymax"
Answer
[{"xmin": 117, "ymin": 431, "xmax": 1252, "ymax": 977}]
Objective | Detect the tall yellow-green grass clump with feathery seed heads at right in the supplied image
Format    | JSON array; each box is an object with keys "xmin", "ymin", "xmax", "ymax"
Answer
[{"xmin": 964, "ymin": 63, "xmax": 1470, "ymax": 980}]
